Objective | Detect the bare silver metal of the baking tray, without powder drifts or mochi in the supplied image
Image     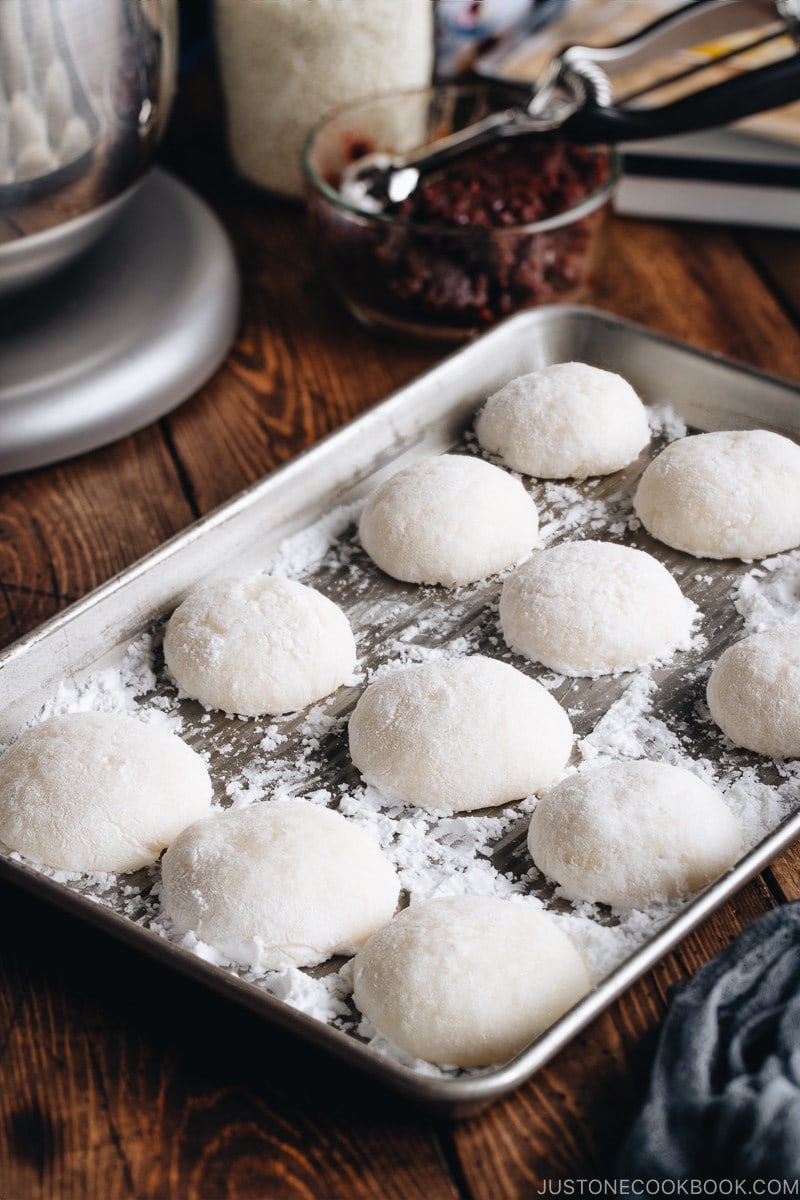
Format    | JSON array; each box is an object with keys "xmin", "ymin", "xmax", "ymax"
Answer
[{"xmin": 0, "ymin": 306, "xmax": 800, "ymax": 1116}]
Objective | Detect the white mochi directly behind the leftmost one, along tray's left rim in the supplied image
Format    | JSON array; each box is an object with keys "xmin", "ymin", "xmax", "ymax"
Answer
[{"xmin": 164, "ymin": 575, "xmax": 356, "ymax": 716}]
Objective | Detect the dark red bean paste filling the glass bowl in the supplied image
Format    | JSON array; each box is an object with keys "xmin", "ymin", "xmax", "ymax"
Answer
[{"xmin": 319, "ymin": 136, "xmax": 609, "ymax": 331}]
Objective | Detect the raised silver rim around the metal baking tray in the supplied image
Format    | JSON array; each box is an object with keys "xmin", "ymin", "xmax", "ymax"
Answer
[{"xmin": 0, "ymin": 305, "xmax": 800, "ymax": 1117}]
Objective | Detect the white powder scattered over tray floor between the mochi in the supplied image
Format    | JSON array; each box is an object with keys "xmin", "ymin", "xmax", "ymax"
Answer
[{"xmin": 1, "ymin": 410, "xmax": 800, "ymax": 1074}]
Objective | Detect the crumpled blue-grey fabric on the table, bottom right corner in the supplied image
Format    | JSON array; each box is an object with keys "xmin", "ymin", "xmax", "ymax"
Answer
[{"xmin": 618, "ymin": 902, "xmax": 800, "ymax": 1180}]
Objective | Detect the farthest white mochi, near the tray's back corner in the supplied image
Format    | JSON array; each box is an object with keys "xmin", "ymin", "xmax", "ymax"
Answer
[{"xmin": 475, "ymin": 362, "xmax": 650, "ymax": 479}]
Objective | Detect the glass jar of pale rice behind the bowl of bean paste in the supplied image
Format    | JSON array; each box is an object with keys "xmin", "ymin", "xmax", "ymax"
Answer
[{"xmin": 215, "ymin": 0, "xmax": 434, "ymax": 197}]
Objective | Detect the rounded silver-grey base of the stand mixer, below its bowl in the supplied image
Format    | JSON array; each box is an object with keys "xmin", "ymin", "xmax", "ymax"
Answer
[{"xmin": 0, "ymin": 169, "xmax": 239, "ymax": 473}]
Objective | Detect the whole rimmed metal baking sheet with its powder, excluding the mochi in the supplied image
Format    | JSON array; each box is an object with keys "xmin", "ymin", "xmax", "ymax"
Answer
[{"xmin": 0, "ymin": 307, "xmax": 800, "ymax": 1116}]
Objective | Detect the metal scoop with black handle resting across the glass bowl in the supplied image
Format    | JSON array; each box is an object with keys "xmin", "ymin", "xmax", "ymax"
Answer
[{"xmin": 339, "ymin": 0, "xmax": 800, "ymax": 212}]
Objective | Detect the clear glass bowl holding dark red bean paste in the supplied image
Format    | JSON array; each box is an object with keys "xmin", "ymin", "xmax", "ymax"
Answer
[{"xmin": 303, "ymin": 84, "xmax": 619, "ymax": 341}]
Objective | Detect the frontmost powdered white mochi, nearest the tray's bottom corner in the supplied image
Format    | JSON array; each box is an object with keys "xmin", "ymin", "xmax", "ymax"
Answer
[{"xmin": 354, "ymin": 896, "xmax": 591, "ymax": 1067}]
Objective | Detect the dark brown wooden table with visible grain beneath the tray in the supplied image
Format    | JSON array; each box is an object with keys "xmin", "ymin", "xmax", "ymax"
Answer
[{"xmin": 0, "ymin": 70, "xmax": 800, "ymax": 1200}]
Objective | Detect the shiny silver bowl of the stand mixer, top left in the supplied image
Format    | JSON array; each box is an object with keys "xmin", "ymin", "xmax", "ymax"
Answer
[{"xmin": 0, "ymin": 0, "xmax": 178, "ymax": 295}]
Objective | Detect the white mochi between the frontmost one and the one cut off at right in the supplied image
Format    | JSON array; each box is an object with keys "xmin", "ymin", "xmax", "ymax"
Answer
[{"xmin": 528, "ymin": 761, "xmax": 742, "ymax": 908}]
